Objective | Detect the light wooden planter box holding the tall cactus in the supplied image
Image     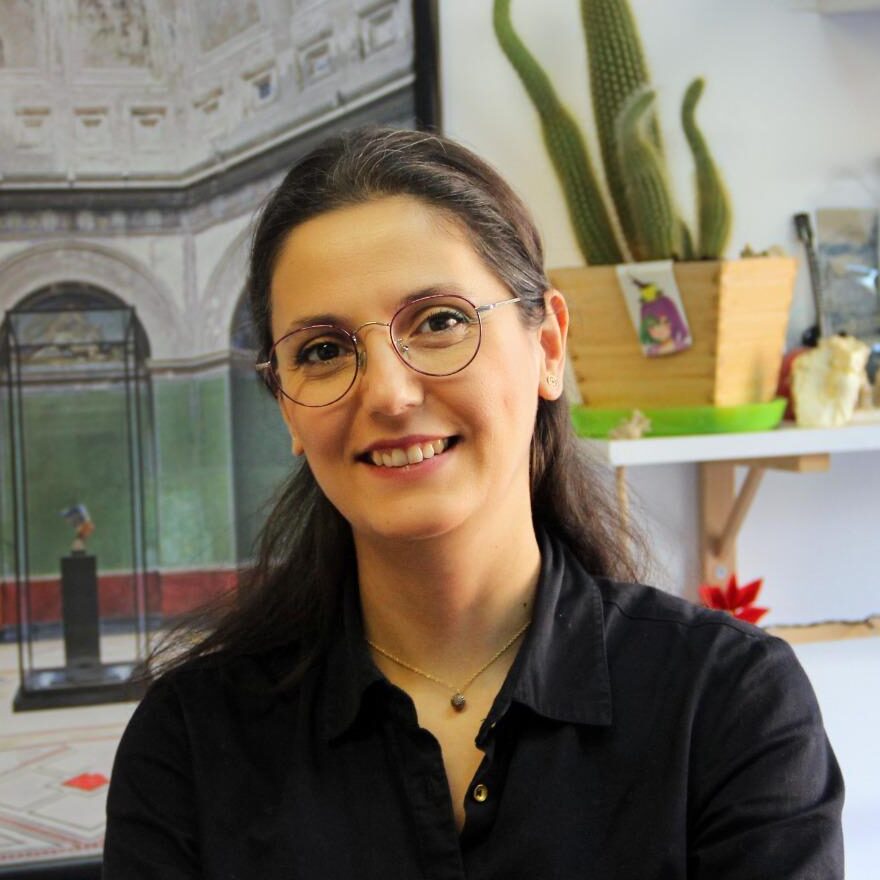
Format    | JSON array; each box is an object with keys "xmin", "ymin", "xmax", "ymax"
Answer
[{"xmin": 549, "ymin": 257, "xmax": 797, "ymax": 408}]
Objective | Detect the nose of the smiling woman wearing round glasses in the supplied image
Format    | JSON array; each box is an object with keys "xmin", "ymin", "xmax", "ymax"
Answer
[{"xmin": 356, "ymin": 322, "xmax": 424, "ymax": 416}]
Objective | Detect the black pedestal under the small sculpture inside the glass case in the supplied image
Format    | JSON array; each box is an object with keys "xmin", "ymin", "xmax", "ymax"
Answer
[{"xmin": 61, "ymin": 553, "xmax": 101, "ymax": 680}]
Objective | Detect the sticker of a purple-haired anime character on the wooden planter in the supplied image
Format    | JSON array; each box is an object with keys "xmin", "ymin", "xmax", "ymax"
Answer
[{"xmin": 616, "ymin": 260, "xmax": 693, "ymax": 357}]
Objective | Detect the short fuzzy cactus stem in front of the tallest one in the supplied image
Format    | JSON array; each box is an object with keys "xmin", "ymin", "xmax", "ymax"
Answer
[{"xmin": 617, "ymin": 89, "xmax": 682, "ymax": 260}]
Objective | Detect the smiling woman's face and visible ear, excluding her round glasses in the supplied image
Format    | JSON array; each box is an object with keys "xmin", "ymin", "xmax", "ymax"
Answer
[{"xmin": 271, "ymin": 196, "xmax": 567, "ymax": 539}]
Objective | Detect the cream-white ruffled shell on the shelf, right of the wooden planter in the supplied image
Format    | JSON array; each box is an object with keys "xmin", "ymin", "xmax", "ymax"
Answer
[{"xmin": 792, "ymin": 336, "xmax": 871, "ymax": 428}]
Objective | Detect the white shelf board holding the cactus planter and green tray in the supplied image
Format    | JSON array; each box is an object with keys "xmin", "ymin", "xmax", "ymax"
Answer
[{"xmin": 585, "ymin": 423, "xmax": 880, "ymax": 467}]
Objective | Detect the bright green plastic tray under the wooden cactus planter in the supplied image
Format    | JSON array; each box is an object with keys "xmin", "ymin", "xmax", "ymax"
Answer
[{"xmin": 571, "ymin": 397, "xmax": 786, "ymax": 437}]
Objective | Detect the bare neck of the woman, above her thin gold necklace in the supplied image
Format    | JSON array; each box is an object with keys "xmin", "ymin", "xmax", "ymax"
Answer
[{"xmin": 355, "ymin": 520, "xmax": 540, "ymax": 681}]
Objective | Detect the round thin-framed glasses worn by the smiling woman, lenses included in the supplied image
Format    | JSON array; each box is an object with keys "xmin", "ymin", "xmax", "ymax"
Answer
[{"xmin": 256, "ymin": 294, "xmax": 519, "ymax": 406}]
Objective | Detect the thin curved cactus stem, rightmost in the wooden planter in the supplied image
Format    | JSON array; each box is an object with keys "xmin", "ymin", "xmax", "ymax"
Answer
[{"xmin": 681, "ymin": 77, "xmax": 731, "ymax": 260}]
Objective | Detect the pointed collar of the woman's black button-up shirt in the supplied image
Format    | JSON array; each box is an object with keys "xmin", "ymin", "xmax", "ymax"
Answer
[{"xmin": 324, "ymin": 530, "xmax": 611, "ymax": 740}]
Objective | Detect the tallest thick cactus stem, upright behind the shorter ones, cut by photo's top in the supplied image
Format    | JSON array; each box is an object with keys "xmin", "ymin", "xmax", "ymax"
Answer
[{"xmin": 581, "ymin": 0, "xmax": 663, "ymax": 259}]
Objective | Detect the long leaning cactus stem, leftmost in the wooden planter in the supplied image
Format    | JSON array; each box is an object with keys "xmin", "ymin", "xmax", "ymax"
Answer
[{"xmin": 493, "ymin": 0, "xmax": 623, "ymax": 265}]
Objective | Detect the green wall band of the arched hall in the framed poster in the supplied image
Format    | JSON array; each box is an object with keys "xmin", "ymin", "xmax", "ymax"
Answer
[{"xmin": 0, "ymin": 367, "xmax": 293, "ymax": 577}]
